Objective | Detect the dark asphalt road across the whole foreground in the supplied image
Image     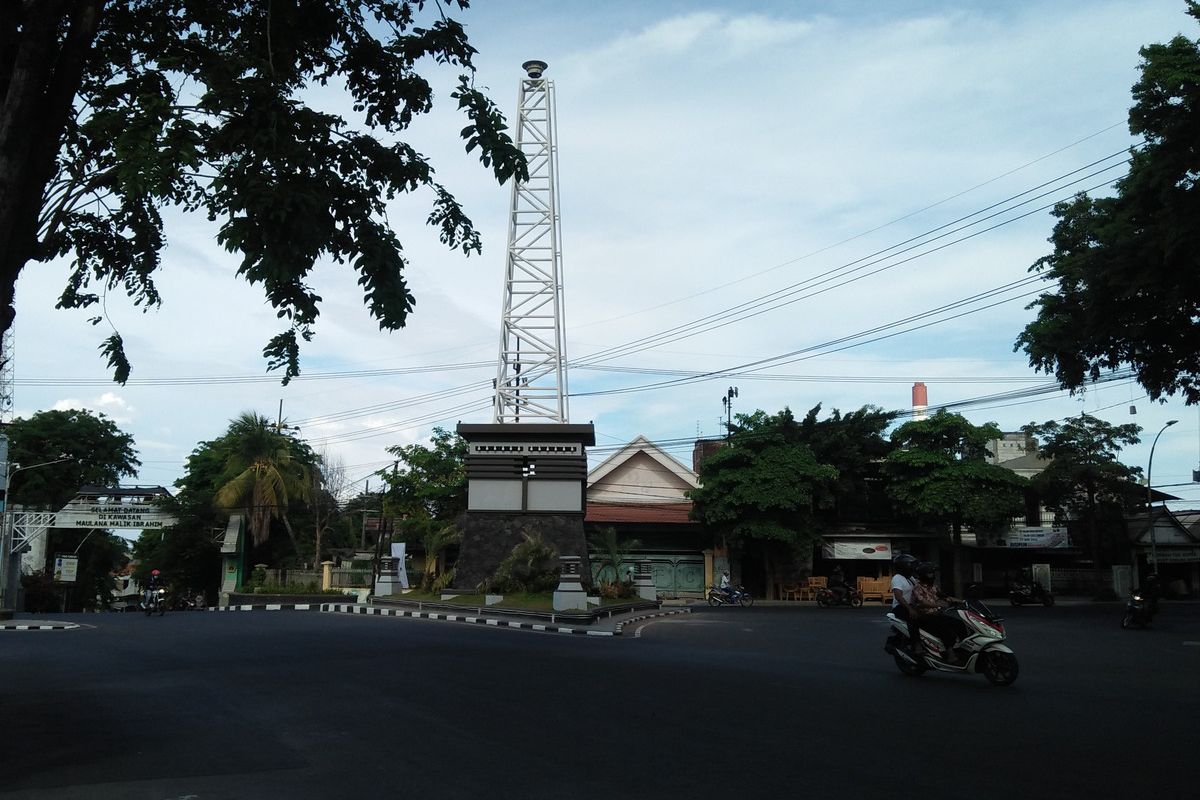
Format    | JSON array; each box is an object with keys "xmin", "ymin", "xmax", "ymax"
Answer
[{"xmin": 0, "ymin": 604, "xmax": 1200, "ymax": 800}]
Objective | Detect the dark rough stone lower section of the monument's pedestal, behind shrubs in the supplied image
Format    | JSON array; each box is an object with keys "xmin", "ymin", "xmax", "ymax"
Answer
[{"xmin": 454, "ymin": 511, "xmax": 592, "ymax": 591}]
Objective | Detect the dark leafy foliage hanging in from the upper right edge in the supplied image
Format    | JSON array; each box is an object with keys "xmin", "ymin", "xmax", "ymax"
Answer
[{"xmin": 1014, "ymin": 0, "xmax": 1200, "ymax": 404}]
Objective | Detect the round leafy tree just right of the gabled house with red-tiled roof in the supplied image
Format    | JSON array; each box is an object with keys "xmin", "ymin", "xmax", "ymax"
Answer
[{"xmin": 689, "ymin": 408, "xmax": 838, "ymax": 594}]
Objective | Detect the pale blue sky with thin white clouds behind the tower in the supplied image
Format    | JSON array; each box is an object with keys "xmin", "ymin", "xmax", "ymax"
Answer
[{"xmin": 13, "ymin": 0, "xmax": 1200, "ymax": 509}]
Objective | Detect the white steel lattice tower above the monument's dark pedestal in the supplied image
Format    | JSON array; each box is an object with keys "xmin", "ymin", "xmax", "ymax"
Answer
[{"xmin": 494, "ymin": 61, "xmax": 569, "ymax": 422}]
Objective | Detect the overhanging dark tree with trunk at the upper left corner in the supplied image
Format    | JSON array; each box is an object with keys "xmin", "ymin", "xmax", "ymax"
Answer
[{"xmin": 0, "ymin": 0, "xmax": 528, "ymax": 383}]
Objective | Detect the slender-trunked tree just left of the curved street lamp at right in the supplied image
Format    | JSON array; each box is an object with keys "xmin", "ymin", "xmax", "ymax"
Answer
[{"xmin": 1025, "ymin": 414, "xmax": 1141, "ymax": 587}]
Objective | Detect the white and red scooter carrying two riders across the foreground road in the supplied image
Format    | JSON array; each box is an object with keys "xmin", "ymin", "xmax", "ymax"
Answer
[{"xmin": 883, "ymin": 601, "xmax": 1019, "ymax": 686}]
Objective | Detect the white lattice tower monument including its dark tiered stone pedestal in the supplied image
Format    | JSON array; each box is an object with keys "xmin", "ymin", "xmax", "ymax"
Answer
[{"xmin": 454, "ymin": 61, "xmax": 595, "ymax": 590}]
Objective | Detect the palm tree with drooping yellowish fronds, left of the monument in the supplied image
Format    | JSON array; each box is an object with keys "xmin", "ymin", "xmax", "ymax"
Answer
[{"xmin": 214, "ymin": 411, "xmax": 312, "ymax": 554}]
